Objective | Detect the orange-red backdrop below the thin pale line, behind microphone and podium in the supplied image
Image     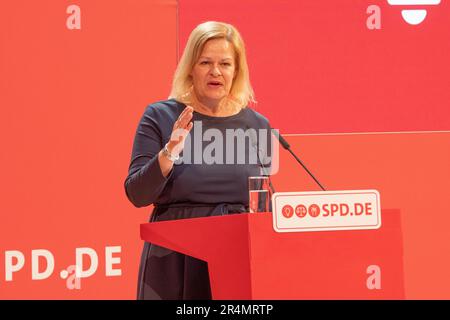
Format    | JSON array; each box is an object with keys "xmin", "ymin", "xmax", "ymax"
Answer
[{"xmin": 273, "ymin": 132, "xmax": 450, "ymax": 299}]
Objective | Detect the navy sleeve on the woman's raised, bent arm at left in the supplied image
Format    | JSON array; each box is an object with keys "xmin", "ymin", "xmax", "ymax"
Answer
[{"xmin": 125, "ymin": 106, "xmax": 173, "ymax": 207}]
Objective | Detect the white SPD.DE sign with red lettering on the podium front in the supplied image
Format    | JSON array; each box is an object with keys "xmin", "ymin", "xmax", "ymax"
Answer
[{"xmin": 272, "ymin": 190, "xmax": 381, "ymax": 232}]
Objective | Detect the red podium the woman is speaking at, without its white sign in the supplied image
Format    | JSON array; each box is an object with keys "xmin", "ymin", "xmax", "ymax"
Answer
[{"xmin": 140, "ymin": 210, "xmax": 405, "ymax": 300}]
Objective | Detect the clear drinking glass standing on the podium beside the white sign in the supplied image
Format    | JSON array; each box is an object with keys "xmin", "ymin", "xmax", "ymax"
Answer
[{"xmin": 248, "ymin": 176, "xmax": 271, "ymax": 213}]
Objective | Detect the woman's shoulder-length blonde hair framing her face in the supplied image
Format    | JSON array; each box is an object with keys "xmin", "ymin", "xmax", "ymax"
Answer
[{"xmin": 169, "ymin": 21, "xmax": 256, "ymax": 108}]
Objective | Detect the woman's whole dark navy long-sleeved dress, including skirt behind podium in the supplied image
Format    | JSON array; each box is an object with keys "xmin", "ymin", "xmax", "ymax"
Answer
[{"xmin": 125, "ymin": 99, "xmax": 271, "ymax": 299}]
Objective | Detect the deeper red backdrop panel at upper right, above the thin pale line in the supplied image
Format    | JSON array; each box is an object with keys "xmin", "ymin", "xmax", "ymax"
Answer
[{"xmin": 179, "ymin": 0, "xmax": 450, "ymax": 133}]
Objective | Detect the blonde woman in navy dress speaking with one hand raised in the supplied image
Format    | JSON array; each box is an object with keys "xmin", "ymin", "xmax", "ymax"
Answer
[{"xmin": 125, "ymin": 21, "xmax": 270, "ymax": 299}]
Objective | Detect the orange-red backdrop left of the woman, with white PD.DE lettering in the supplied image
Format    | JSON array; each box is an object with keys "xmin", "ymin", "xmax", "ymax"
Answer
[{"xmin": 0, "ymin": 0, "xmax": 177, "ymax": 299}]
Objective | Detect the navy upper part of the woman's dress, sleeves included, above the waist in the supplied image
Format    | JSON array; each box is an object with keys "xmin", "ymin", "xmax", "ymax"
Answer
[{"xmin": 125, "ymin": 99, "xmax": 270, "ymax": 207}]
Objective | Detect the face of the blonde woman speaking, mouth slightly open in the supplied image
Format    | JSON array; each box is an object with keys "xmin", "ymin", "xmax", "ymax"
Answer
[{"xmin": 191, "ymin": 39, "xmax": 236, "ymax": 106}]
